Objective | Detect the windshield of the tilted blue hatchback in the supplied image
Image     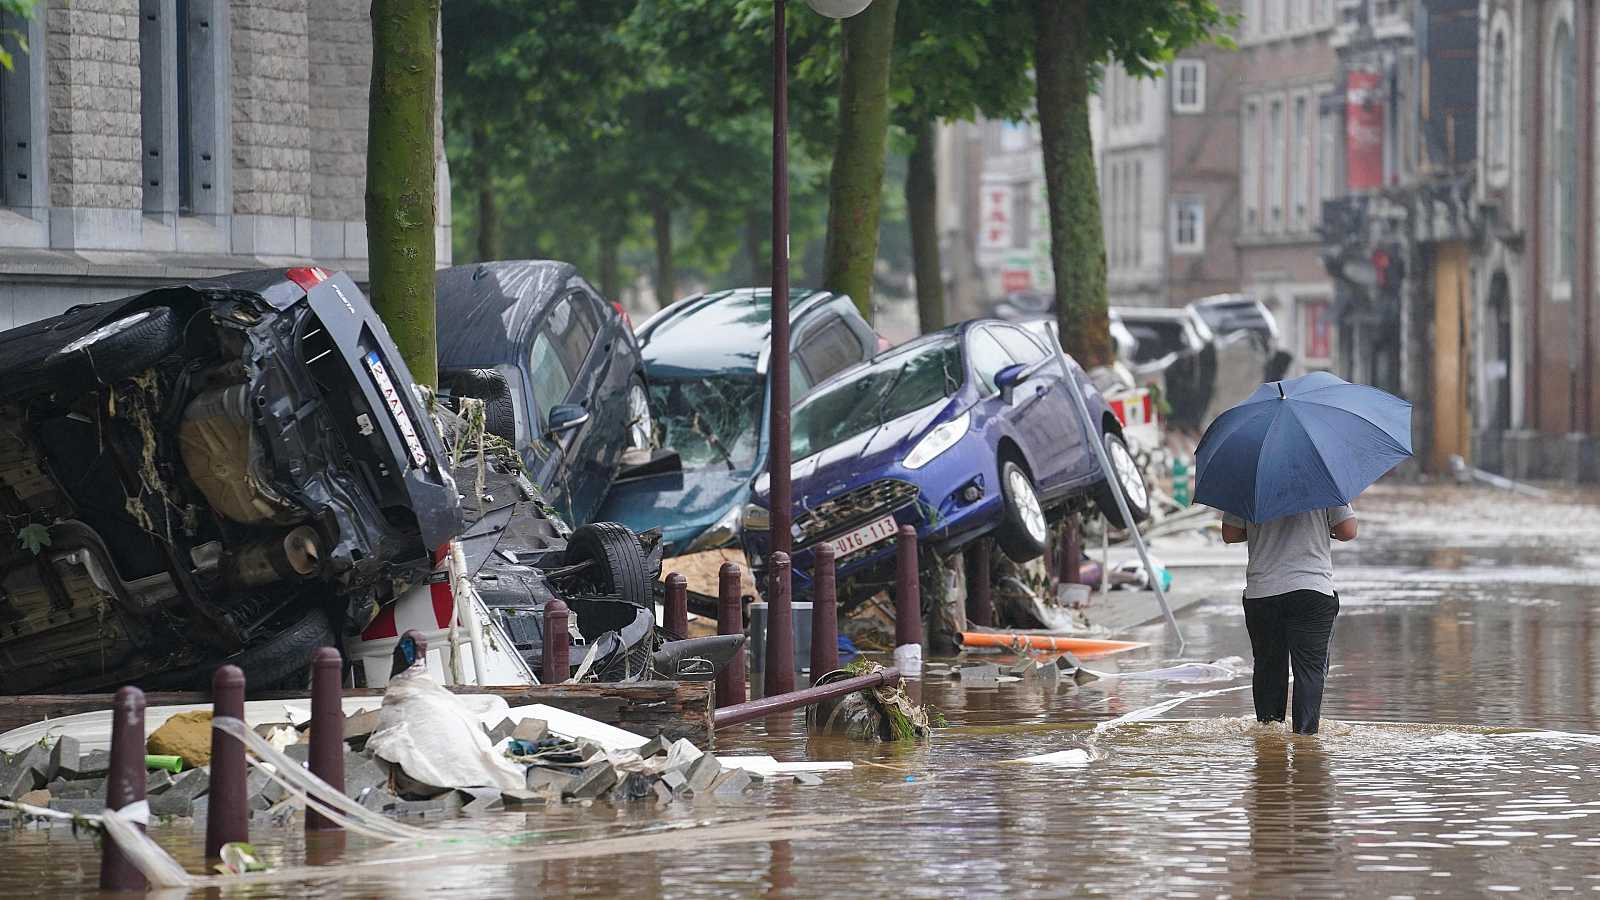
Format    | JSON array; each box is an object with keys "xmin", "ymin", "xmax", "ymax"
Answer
[{"xmin": 790, "ymin": 336, "xmax": 965, "ymax": 460}]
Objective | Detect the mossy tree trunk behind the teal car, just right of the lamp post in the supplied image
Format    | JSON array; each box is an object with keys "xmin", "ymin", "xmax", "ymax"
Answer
[{"xmin": 822, "ymin": 0, "xmax": 899, "ymax": 322}]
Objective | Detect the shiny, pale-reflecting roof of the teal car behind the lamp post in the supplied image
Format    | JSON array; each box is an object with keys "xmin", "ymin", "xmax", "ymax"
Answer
[{"xmin": 638, "ymin": 288, "xmax": 843, "ymax": 375}]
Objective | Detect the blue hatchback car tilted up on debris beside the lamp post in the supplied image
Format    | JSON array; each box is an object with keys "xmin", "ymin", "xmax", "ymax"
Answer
[{"xmin": 744, "ymin": 319, "xmax": 1149, "ymax": 602}]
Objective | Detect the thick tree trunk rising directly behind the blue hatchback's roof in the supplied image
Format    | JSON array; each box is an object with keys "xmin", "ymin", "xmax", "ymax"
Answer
[{"xmin": 1034, "ymin": 0, "xmax": 1112, "ymax": 367}]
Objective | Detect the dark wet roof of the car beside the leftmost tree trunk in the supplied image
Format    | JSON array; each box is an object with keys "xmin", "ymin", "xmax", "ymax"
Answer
[{"xmin": 434, "ymin": 259, "xmax": 582, "ymax": 368}]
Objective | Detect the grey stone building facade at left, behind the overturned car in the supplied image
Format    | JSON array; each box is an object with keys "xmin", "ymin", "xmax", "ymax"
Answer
[{"xmin": 0, "ymin": 0, "xmax": 450, "ymax": 328}]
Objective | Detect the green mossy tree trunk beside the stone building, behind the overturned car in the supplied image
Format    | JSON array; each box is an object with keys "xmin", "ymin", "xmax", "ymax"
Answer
[{"xmin": 366, "ymin": 0, "xmax": 440, "ymax": 386}]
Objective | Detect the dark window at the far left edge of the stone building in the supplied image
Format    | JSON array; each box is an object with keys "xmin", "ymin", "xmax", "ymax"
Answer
[{"xmin": 0, "ymin": 10, "xmax": 39, "ymax": 210}]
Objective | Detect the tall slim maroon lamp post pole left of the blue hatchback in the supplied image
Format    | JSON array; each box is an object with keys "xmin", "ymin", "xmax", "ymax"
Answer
[{"xmin": 766, "ymin": 0, "xmax": 792, "ymax": 554}]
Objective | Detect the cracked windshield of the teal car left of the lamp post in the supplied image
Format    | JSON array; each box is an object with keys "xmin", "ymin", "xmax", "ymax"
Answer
[{"xmin": 650, "ymin": 372, "xmax": 766, "ymax": 471}]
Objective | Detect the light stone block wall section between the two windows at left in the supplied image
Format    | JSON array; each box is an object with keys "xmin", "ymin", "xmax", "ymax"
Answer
[{"xmin": 45, "ymin": 0, "xmax": 144, "ymax": 210}]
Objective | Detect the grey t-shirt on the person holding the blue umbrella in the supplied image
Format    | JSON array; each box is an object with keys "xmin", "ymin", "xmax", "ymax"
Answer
[{"xmin": 1222, "ymin": 506, "xmax": 1355, "ymax": 599}]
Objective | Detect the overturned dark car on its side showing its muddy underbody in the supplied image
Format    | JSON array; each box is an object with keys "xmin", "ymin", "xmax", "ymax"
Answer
[{"xmin": 0, "ymin": 269, "xmax": 462, "ymax": 693}]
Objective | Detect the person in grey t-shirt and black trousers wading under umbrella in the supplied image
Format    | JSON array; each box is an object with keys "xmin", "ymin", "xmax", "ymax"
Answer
[{"xmin": 1222, "ymin": 506, "xmax": 1355, "ymax": 735}]
